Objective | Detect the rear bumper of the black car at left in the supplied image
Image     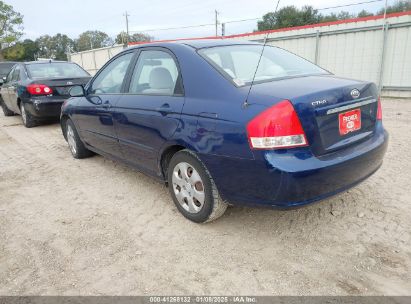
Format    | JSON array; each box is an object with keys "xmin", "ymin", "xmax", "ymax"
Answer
[{"xmin": 23, "ymin": 96, "xmax": 66, "ymax": 120}]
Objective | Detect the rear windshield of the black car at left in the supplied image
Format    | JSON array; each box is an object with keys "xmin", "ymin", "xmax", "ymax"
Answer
[{"xmin": 27, "ymin": 62, "xmax": 90, "ymax": 79}]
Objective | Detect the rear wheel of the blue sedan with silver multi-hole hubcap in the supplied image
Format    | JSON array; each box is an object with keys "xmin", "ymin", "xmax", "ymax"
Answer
[{"xmin": 167, "ymin": 150, "xmax": 227, "ymax": 223}]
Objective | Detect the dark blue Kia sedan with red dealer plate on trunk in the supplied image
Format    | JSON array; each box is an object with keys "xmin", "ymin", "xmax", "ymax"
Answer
[{"xmin": 61, "ymin": 40, "xmax": 388, "ymax": 223}]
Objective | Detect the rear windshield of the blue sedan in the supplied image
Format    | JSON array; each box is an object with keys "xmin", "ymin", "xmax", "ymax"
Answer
[{"xmin": 199, "ymin": 45, "xmax": 329, "ymax": 86}]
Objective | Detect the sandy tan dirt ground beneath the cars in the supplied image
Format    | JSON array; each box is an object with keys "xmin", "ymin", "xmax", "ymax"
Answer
[{"xmin": 0, "ymin": 100, "xmax": 411, "ymax": 295}]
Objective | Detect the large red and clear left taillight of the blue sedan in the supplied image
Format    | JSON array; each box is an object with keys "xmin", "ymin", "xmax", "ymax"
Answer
[{"xmin": 247, "ymin": 100, "xmax": 308, "ymax": 149}]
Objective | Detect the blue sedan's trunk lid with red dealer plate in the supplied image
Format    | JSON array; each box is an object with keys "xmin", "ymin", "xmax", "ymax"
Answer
[{"xmin": 250, "ymin": 75, "xmax": 378, "ymax": 155}]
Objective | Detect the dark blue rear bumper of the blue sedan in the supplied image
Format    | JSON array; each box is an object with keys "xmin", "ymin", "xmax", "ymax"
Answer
[{"xmin": 201, "ymin": 123, "xmax": 388, "ymax": 208}]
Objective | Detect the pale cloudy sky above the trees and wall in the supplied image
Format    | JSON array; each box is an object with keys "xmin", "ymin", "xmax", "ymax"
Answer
[{"xmin": 8, "ymin": 0, "xmax": 394, "ymax": 40}]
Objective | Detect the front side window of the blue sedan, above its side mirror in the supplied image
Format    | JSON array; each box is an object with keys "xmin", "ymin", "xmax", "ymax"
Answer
[{"xmin": 91, "ymin": 53, "xmax": 134, "ymax": 94}]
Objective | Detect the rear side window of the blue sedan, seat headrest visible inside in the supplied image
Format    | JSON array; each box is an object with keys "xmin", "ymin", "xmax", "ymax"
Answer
[{"xmin": 129, "ymin": 51, "xmax": 179, "ymax": 95}]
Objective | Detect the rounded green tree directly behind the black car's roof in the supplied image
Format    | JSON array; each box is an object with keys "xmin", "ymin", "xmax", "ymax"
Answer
[{"xmin": 36, "ymin": 33, "xmax": 74, "ymax": 60}]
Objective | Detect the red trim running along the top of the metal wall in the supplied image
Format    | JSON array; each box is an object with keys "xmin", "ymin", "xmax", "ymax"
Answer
[{"xmin": 129, "ymin": 11, "xmax": 411, "ymax": 45}]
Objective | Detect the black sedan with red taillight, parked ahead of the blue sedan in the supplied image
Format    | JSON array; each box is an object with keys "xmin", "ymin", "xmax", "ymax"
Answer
[{"xmin": 0, "ymin": 61, "xmax": 91, "ymax": 128}]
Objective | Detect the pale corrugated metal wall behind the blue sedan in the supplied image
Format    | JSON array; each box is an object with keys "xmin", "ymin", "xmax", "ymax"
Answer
[{"xmin": 67, "ymin": 12, "xmax": 411, "ymax": 97}]
